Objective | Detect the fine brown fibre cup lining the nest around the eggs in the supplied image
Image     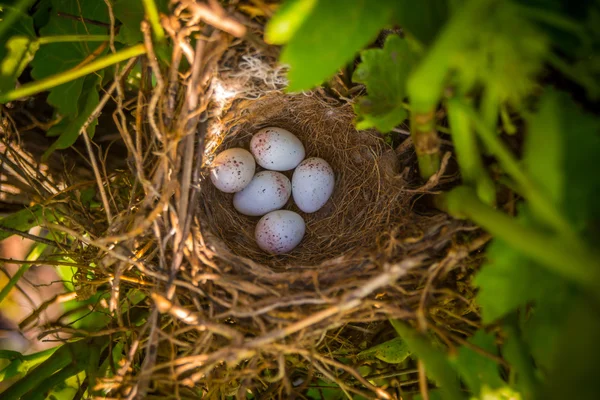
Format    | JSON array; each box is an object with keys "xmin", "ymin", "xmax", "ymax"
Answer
[{"xmin": 201, "ymin": 92, "xmax": 409, "ymax": 267}]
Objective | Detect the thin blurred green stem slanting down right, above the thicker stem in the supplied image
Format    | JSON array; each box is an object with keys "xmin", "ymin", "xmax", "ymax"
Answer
[{"xmin": 455, "ymin": 102, "xmax": 576, "ymax": 240}]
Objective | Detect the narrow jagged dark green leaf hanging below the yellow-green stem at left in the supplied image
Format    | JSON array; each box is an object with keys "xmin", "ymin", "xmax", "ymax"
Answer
[{"xmin": 43, "ymin": 72, "xmax": 103, "ymax": 159}]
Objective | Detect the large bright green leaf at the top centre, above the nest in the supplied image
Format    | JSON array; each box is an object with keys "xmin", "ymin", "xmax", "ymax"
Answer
[{"xmin": 280, "ymin": 0, "xmax": 395, "ymax": 91}]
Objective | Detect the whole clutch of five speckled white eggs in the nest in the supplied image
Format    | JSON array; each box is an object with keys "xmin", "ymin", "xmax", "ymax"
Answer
[{"xmin": 210, "ymin": 127, "xmax": 335, "ymax": 254}]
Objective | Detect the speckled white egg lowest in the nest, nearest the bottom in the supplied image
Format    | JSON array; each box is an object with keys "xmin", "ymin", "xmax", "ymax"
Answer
[{"xmin": 254, "ymin": 210, "xmax": 306, "ymax": 254}]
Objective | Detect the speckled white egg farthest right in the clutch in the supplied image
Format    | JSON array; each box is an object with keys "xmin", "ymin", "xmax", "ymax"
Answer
[{"xmin": 292, "ymin": 157, "xmax": 335, "ymax": 213}]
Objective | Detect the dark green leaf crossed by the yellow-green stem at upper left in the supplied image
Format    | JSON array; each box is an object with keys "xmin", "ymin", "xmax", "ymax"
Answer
[{"xmin": 31, "ymin": 0, "xmax": 109, "ymax": 117}]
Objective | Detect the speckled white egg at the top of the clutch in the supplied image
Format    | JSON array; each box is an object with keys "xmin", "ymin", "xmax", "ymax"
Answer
[{"xmin": 250, "ymin": 127, "xmax": 305, "ymax": 171}]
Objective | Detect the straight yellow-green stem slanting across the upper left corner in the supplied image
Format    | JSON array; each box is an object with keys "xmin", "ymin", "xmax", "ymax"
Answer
[{"xmin": 0, "ymin": 44, "xmax": 146, "ymax": 104}]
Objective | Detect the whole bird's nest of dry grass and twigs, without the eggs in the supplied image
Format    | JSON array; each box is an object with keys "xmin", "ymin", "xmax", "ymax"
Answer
[{"xmin": 1, "ymin": 4, "xmax": 487, "ymax": 399}]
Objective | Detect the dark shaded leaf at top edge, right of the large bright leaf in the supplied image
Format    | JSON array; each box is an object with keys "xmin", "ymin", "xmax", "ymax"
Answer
[{"xmin": 394, "ymin": 0, "xmax": 449, "ymax": 45}]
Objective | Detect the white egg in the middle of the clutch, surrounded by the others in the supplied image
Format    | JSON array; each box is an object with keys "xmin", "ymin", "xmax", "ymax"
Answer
[{"xmin": 233, "ymin": 171, "xmax": 292, "ymax": 216}]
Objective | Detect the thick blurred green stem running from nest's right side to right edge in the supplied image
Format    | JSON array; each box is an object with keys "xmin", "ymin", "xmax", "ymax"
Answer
[{"xmin": 436, "ymin": 186, "xmax": 600, "ymax": 297}]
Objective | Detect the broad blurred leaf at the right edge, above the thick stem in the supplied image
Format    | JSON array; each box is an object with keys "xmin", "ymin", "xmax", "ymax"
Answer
[{"xmin": 523, "ymin": 89, "xmax": 600, "ymax": 238}]
